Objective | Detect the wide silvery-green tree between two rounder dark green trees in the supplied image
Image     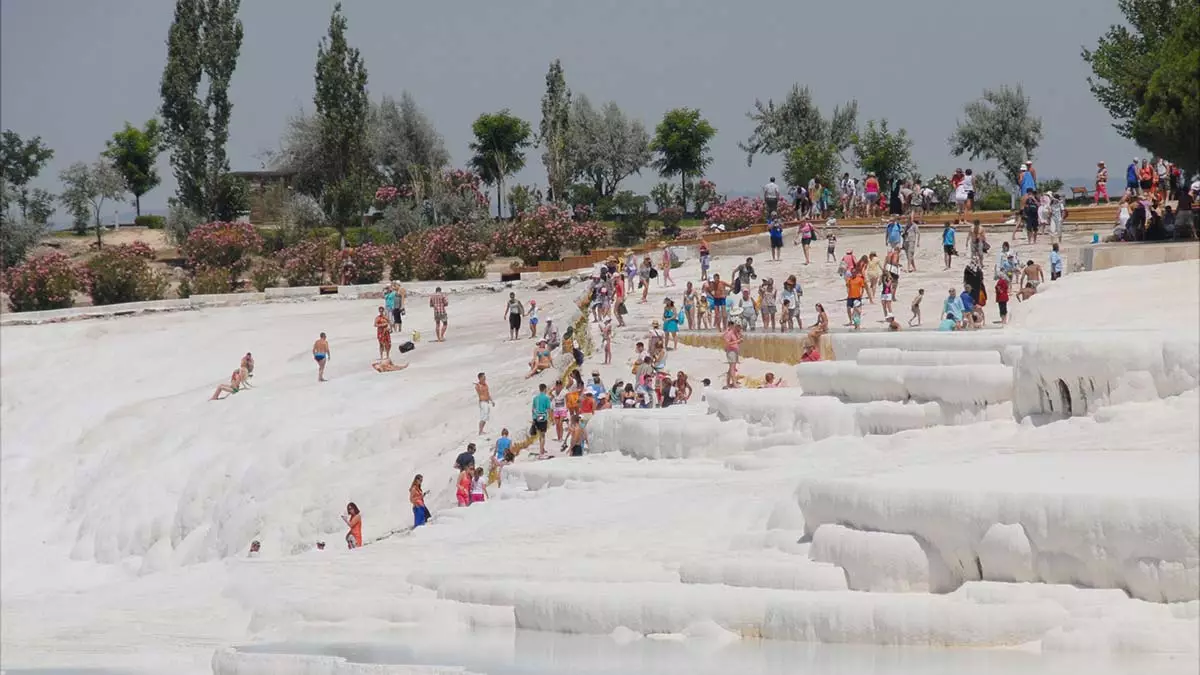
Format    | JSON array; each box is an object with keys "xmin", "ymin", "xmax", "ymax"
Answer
[{"xmin": 738, "ymin": 84, "xmax": 858, "ymax": 168}]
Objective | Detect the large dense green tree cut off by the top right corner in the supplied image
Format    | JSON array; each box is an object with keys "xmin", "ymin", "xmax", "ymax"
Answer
[{"xmin": 1082, "ymin": 0, "xmax": 1200, "ymax": 173}]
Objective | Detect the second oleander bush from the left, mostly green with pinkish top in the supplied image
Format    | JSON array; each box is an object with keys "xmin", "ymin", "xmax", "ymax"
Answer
[{"xmin": 82, "ymin": 241, "xmax": 168, "ymax": 305}]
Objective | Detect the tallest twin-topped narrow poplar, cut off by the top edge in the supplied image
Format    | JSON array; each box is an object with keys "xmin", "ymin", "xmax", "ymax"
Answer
[{"xmin": 160, "ymin": 0, "xmax": 242, "ymax": 216}]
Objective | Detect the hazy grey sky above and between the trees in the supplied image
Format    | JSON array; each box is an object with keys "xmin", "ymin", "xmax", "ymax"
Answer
[{"xmin": 0, "ymin": 0, "xmax": 1139, "ymax": 210}]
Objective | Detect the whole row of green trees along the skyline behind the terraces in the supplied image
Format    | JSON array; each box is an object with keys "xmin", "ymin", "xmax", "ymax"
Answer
[{"xmin": 0, "ymin": 0, "xmax": 1200, "ymax": 264}]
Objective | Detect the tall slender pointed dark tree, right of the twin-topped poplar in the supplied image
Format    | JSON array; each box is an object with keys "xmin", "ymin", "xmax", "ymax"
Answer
[{"xmin": 313, "ymin": 2, "xmax": 374, "ymax": 231}]
